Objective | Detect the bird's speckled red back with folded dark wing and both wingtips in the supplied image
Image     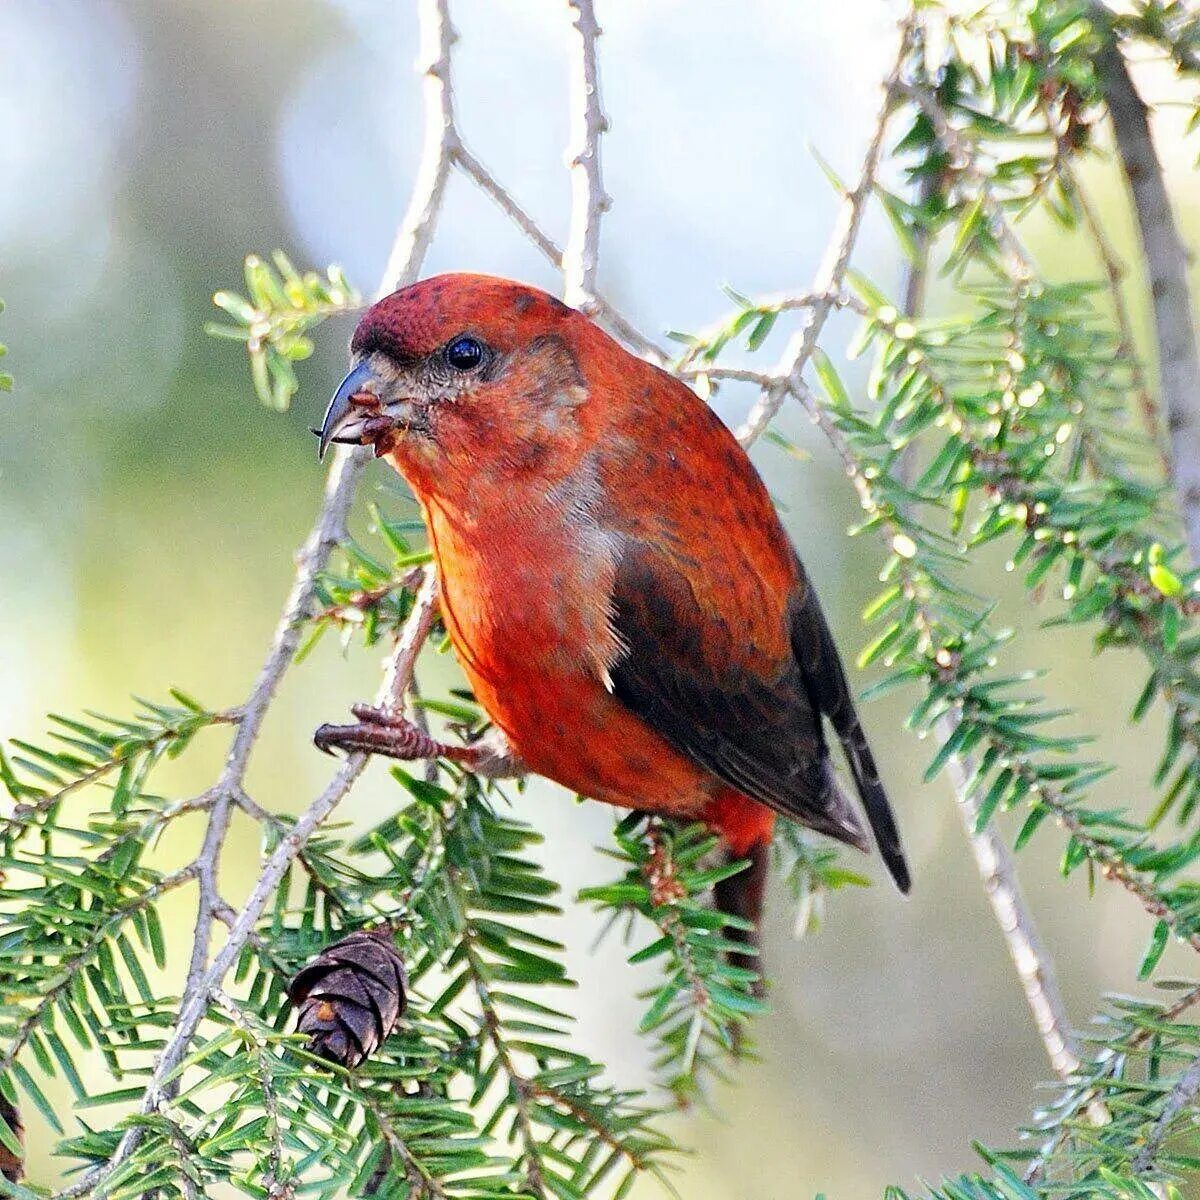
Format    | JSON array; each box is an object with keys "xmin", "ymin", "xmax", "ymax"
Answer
[{"xmin": 589, "ymin": 365, "xmax": 908, "ymax": 892}]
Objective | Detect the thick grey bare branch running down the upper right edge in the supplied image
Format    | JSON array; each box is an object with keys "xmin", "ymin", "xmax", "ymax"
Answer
[{"xmin": 1093, "ymin": 21, "xmax": 1200, "ymax": 563}]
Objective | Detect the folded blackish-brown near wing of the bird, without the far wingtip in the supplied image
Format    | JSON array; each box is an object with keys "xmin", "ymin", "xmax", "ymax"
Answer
[{"xmin": 611, "ymin": 540, "xmax": 868, "ymax": 850}]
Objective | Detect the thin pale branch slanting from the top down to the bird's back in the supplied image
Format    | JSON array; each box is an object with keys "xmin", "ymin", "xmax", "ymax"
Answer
[{"xmin": 738, "ymin": 12, "xmax": 917, "ymax": 445}]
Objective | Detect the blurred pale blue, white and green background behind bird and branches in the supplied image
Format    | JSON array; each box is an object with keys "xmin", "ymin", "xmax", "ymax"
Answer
[{"xmin": 0, "ymin": 0, "xmax": 1200, "ymax": 1200}]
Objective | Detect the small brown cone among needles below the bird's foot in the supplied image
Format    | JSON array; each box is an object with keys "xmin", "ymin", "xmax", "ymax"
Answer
[{"xmin": 288, "ymin": 929, "xmax": 408, "ymax": 1067}]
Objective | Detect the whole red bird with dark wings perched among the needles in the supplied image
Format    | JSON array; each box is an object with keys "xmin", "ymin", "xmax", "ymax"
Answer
[{"xmin": 317, "ymin": 275, "xmax": 910, "ymax": 964}]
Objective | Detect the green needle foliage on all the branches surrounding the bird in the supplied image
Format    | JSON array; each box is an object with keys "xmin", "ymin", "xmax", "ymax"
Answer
[{"xmin": 0, "ymin": 0, "xmax": 1200, "ymax": 1200}]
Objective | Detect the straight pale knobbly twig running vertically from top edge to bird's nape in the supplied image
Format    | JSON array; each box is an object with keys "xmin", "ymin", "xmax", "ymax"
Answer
[{"xmin": 563, "ymin": 0, "xmax": 610, "ymax": 311}]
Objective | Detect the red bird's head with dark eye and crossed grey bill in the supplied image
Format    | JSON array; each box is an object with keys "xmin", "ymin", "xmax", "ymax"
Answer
[{"xmin": 319, "ymin": 275, "xmax": 607, "ymax": 492}]
